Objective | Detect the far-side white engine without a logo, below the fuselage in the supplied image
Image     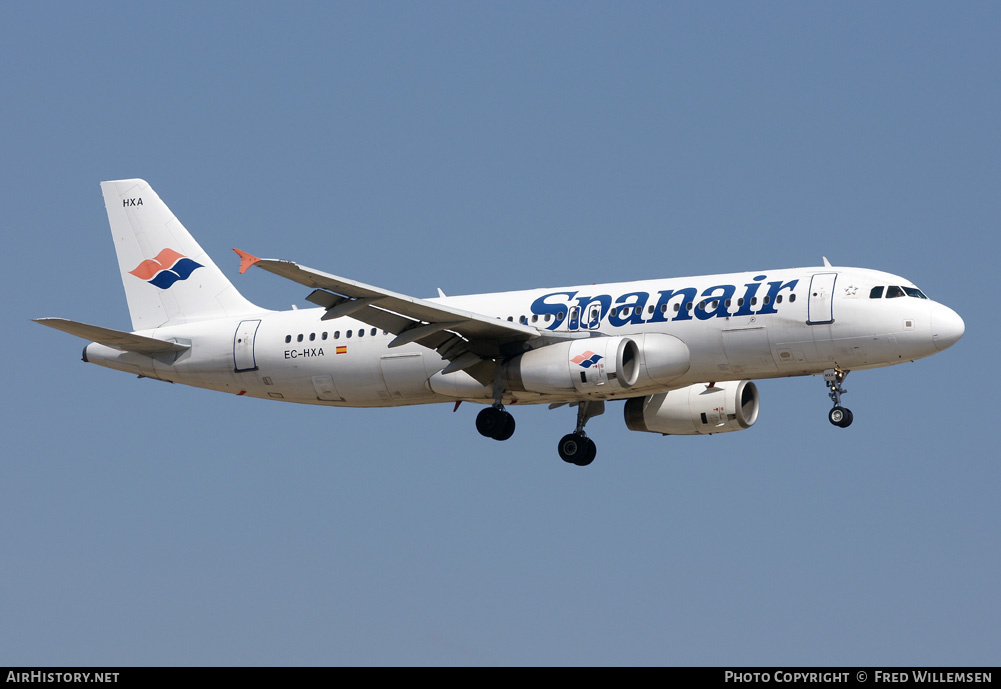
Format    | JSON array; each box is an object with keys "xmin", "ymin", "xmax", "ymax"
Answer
[{"xmin": 625, "ymin": 381, "xmax": 759, "ymax": 436}]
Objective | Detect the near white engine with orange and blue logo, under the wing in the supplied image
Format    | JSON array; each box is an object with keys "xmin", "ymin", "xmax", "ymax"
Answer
[{"xmin": 505, "ymin": 337, "xmax": 641, "ymax": 395}]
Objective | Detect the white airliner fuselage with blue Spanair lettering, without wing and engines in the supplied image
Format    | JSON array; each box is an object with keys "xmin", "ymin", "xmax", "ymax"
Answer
[{"xmin": 84, "ymin": 266, "xmax": 963, "ymax": 407}]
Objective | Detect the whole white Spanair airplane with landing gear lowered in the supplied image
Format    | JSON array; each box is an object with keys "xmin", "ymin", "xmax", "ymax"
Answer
[{"xmin": 35, "ymin": 179, "xmax": 965, "ymax": 467}]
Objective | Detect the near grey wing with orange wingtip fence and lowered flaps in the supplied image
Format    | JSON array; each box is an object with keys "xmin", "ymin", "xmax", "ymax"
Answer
[{"xmin": 233, "ymin": 249, "xmax": 552, "ymax": 385}]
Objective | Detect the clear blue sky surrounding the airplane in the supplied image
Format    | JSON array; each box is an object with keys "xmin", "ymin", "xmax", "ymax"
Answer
[{"xmin": 0, "ymin": 2, "xmax": 1001, "ymax": 666}]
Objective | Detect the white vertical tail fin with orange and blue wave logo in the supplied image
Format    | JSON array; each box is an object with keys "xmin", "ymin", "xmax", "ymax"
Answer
[{"xmin": 101, "ymin": 179, "xmax": 262, "ymax": 330}]
